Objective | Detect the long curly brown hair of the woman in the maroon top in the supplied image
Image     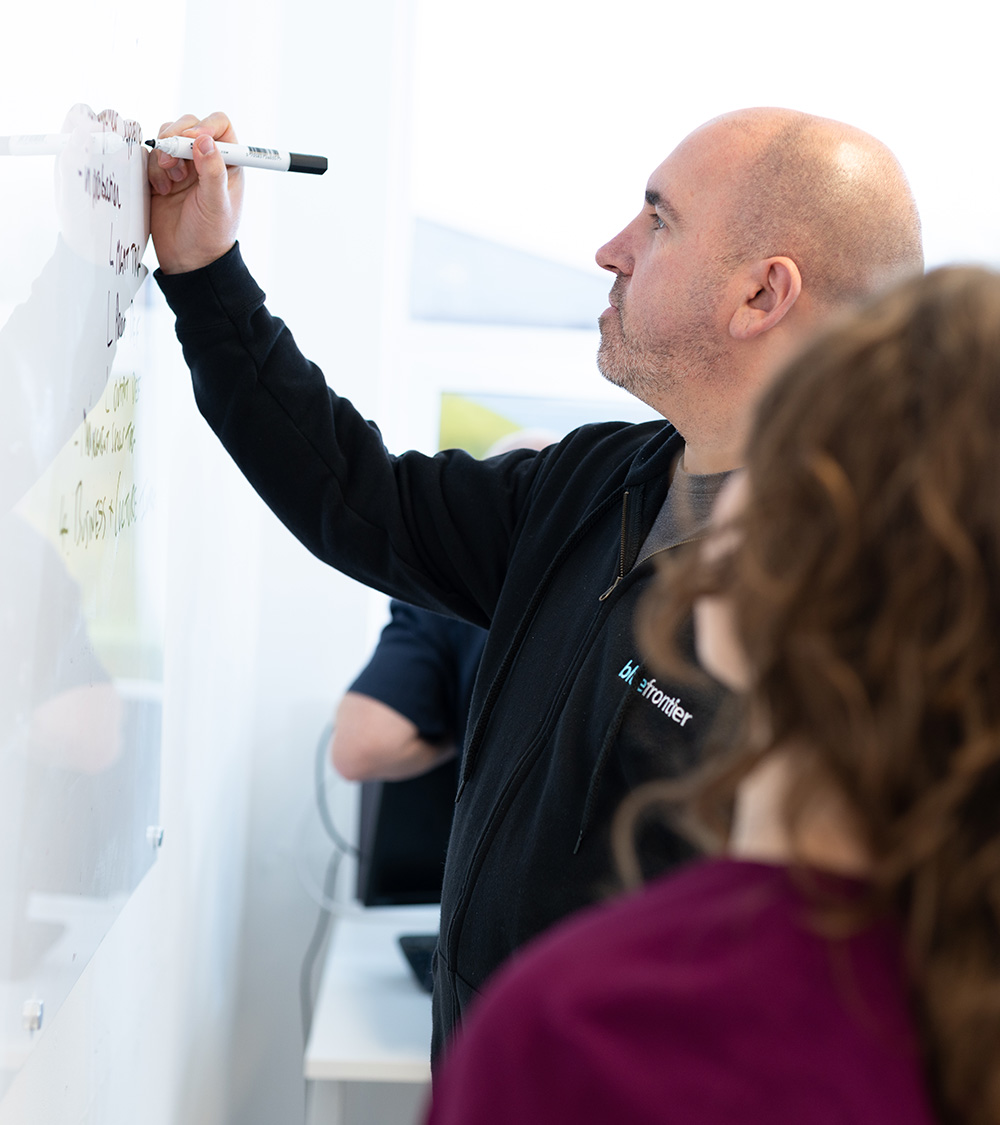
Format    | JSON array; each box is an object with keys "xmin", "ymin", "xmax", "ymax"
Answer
[{"xmin": 639, "ymin": 268, "xmax": 1000, "ymax": 1125}]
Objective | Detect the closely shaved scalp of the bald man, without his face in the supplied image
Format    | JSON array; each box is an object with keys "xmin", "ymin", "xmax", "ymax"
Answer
[{"xmin": 690, "ymin": 109, "xmax": 924, "ymax": 307}]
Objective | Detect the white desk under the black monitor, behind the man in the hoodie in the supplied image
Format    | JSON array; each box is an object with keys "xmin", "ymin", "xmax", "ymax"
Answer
[{"xmin": 305, "ymin": 907, "xmax": 439, "ymax": 1125}]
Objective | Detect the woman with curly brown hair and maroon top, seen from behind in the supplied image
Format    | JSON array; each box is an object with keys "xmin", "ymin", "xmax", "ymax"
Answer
[{"xmin": 420, "ymin": 268, "xmax": 1000, "ymax": 1125}]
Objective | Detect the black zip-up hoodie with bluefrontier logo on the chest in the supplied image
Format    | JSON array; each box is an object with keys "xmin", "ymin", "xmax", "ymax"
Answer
[{"xmin": 156, "ymin": 248, "xmax": 718, "ymax": 1052}]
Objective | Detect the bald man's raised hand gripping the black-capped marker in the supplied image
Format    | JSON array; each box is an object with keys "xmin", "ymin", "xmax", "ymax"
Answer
[{"xmin": 148, "ymin": 113, "xmax": 243, "ymax": 273}]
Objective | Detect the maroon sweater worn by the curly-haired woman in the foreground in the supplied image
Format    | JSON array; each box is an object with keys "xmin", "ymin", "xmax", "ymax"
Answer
[{"xmin": 429, "ymin": 860, "xmax": 933, "ymax": 1125}]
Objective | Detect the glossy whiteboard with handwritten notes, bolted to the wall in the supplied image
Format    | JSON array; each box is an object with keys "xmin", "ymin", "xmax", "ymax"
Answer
[{"xmin": 0, "ymin": 105, "xmax": 164, "ymax": 1097}]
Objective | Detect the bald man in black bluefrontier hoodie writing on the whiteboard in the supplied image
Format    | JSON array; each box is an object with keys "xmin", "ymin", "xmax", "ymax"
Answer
[{"xmin": 150, "ymin": 109, "xmax": 922, "ymax": 1051}]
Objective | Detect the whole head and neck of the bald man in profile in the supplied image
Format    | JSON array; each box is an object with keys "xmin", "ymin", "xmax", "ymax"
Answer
[{"xmin": 597, "ymin": 109, "xmax": 924, "ymax": 473}]
